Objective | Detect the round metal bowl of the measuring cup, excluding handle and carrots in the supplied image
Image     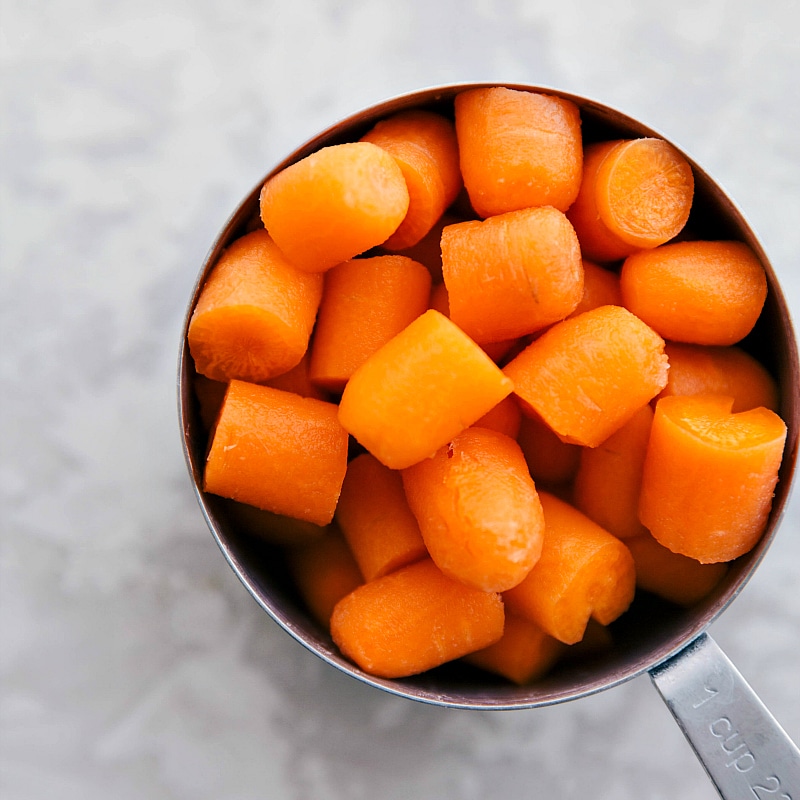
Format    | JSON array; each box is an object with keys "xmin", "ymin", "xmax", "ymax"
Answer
[{"xmin": 178, "ymin": 83, "xmax": 800, "ymax": 709}]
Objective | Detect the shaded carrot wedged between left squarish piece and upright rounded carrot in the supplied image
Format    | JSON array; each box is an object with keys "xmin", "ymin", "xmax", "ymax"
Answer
[{"xmin": 335, "ymin": 453, "xmax": 428, "ymax": 581}]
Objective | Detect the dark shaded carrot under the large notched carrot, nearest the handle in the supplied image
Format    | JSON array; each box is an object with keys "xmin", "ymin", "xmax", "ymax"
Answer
[{"xmin": 625, "ymin": 532, "xmax": 728, "ymax": 606}]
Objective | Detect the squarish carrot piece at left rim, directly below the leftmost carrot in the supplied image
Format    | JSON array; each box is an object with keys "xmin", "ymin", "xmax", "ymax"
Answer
[{"xmin": 203, "ymin": 381, "xmax": 348, "ymax": 525}]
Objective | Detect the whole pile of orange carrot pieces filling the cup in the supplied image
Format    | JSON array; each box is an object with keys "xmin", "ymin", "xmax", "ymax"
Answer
[{"xmin": 188, "ymin": 87, "xmax": 786, "ymax": 684}]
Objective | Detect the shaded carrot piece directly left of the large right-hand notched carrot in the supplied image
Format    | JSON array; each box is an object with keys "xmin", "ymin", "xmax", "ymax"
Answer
[{"xmin": 573, "ymin": 403, "xmax": 653, "ymax": 540}]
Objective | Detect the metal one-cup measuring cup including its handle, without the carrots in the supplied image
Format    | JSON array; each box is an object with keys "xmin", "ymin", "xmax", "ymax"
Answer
[{"xmin": 178, "ymin": 83, "xmax": 800, "ymax": 800}]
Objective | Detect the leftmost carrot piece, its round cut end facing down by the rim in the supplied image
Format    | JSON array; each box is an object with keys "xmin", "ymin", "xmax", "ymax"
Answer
[{"xmin": 188, "ymin": 230, "xmax": 322, "ymax": 383}]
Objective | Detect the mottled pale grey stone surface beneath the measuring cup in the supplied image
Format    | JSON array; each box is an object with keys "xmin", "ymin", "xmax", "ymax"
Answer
[{"xmin": 0, "ymin": 0, "xmax": 800, "ymax": 800}]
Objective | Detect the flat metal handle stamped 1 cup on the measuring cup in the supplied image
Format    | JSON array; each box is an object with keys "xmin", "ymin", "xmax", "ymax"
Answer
[{"xmin": 650, "ymin": 634, "xmax": 800, "ymax": 800}]
